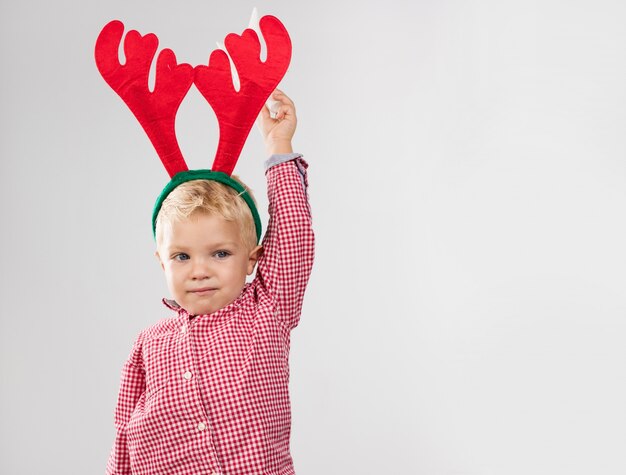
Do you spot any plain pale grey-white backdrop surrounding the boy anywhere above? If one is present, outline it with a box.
[0,0,626,475]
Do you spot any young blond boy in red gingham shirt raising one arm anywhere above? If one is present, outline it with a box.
[107,91,314,475]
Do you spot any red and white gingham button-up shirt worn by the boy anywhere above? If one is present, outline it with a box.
[106,158,314,475]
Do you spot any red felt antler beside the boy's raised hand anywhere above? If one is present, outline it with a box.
[194,15,291,175]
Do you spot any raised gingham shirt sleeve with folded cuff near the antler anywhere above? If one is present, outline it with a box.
[257,155,315,329]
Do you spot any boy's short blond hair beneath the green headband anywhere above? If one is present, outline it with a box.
[156,175,257,249]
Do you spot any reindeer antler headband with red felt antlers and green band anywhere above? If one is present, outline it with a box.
[95,15,291,239]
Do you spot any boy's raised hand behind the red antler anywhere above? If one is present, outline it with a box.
[259,89,298,155]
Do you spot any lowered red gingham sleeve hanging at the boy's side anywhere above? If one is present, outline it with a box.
[106,334,146,475]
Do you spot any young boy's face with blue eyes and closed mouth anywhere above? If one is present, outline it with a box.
[156,213,261,315]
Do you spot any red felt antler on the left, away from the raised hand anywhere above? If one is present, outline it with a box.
[95,20,193,177]
